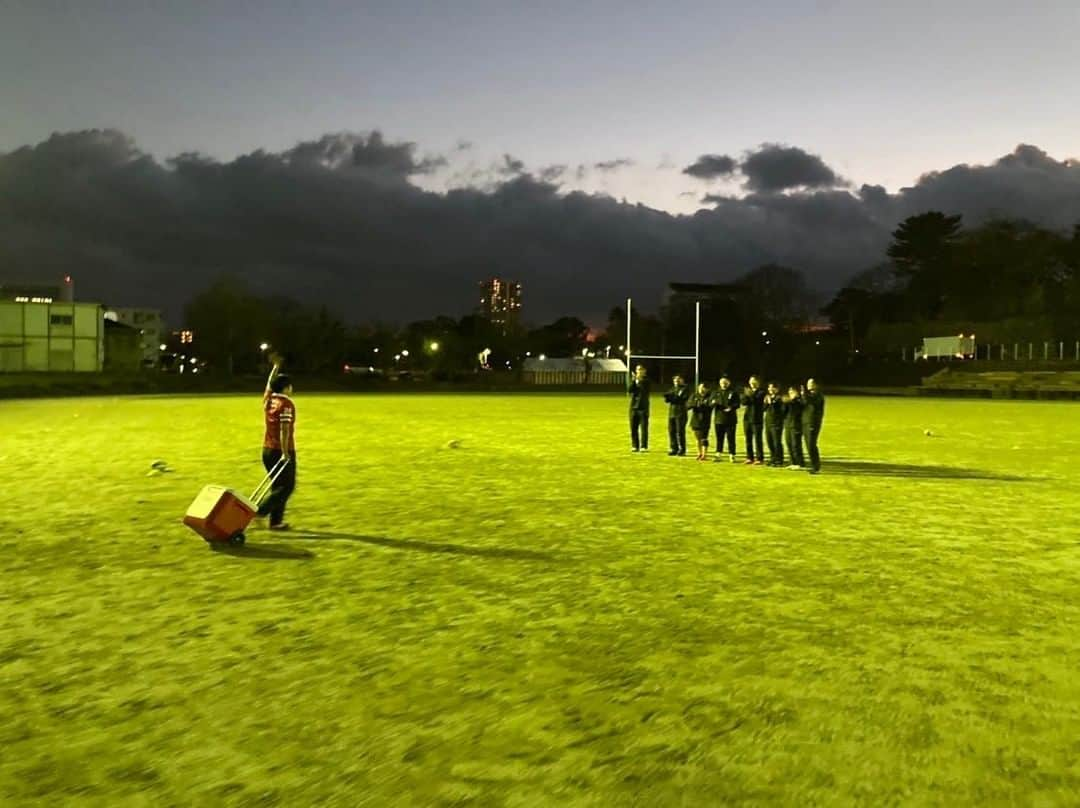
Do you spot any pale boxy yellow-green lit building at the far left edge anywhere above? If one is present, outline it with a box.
[0,298,105,373]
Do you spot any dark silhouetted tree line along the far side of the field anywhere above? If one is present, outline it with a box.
[186,211,1080,379]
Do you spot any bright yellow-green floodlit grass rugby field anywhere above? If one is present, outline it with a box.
[0,391,1080,806]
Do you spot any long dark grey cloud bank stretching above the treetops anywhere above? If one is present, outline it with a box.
[6,131,1080,321]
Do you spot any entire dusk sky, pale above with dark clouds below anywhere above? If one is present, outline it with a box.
[0,0,1080,322]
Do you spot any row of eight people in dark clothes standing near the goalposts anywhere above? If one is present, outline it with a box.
[630,365,825,474]
